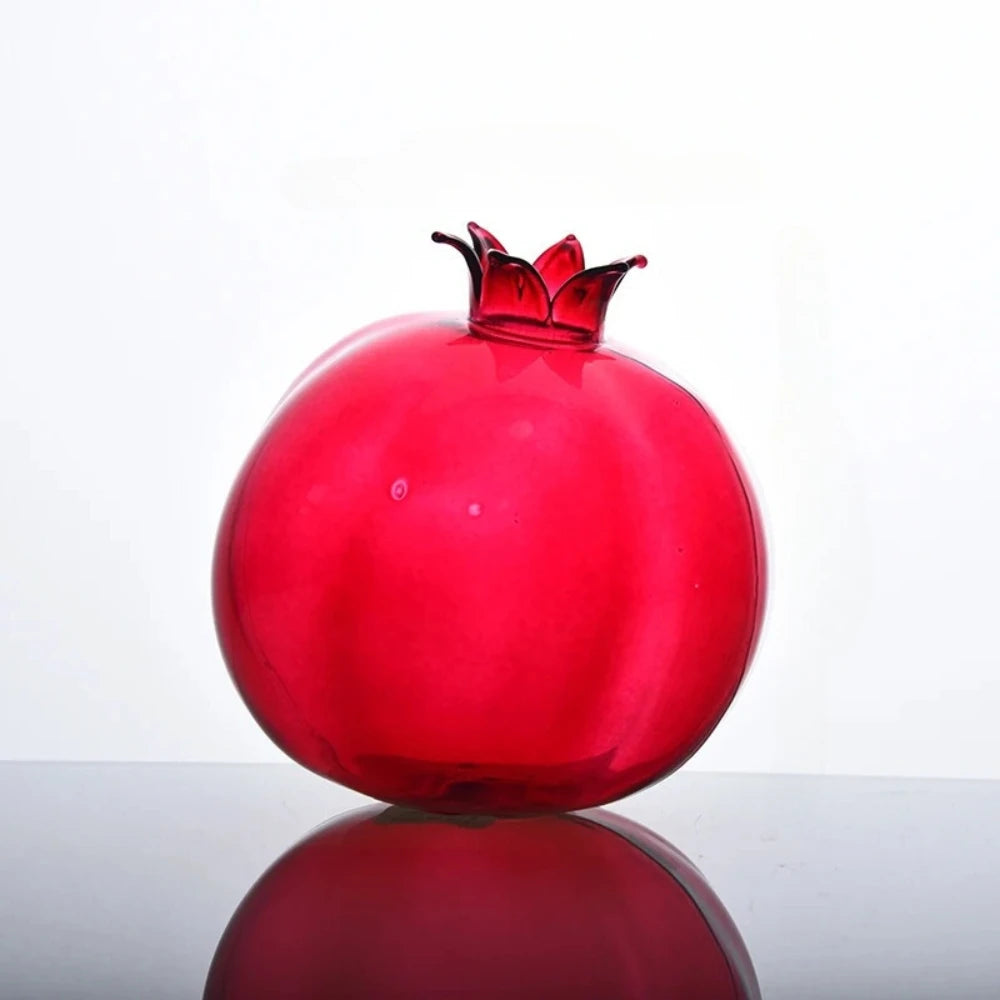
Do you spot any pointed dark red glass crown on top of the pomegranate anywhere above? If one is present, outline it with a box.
[431,222,646,347]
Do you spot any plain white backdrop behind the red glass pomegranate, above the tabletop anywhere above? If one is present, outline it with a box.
[0,0,1000,778]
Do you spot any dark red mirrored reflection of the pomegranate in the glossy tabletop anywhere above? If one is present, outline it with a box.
[205,806,760,1000]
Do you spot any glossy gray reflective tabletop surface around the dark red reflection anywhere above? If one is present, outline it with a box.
[0,764,1000,1000]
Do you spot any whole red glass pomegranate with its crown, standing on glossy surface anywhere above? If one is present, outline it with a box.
[214,225,765,813]
